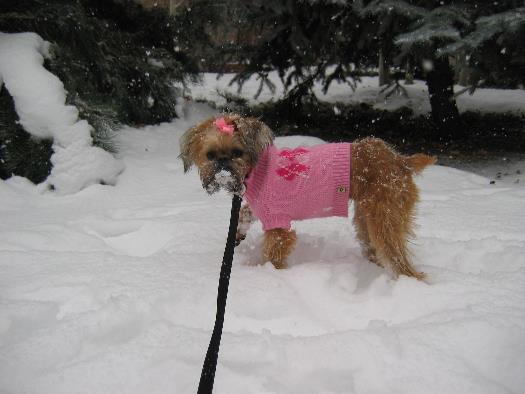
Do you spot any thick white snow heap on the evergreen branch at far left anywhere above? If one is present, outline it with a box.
[0,33,123,194]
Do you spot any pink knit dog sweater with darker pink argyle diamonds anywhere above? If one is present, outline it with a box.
[245,143,351,230]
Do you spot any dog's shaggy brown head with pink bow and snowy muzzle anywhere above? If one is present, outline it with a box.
[180,115,273,194]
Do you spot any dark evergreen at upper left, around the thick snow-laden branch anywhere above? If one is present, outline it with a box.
[0,0,206,182]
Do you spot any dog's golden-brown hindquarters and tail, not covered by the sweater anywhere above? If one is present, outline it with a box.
[350,138,428,279]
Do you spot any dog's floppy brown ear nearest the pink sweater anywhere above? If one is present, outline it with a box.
[233,117,274,164]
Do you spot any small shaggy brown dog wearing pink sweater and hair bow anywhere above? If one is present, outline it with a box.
[179,114,436,280]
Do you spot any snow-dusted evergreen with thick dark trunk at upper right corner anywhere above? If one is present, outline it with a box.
[361,0,525,137]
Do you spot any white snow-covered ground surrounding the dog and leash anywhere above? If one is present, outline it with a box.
[0,102,525,394]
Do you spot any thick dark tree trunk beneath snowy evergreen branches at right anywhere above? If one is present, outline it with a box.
[427,57,462,137]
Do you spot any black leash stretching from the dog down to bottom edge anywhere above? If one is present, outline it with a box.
[197,194,242,394]
